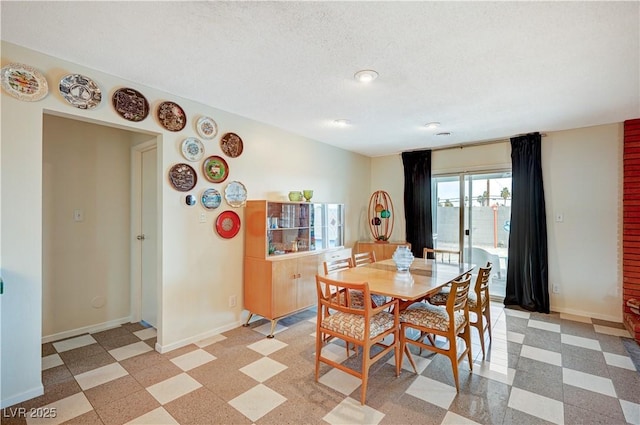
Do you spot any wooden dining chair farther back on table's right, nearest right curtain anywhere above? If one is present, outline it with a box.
[427,262,493,359]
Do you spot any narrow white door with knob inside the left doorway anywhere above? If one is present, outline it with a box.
[140,147,158,327]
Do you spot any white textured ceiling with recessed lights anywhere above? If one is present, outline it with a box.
[0,1,640,156]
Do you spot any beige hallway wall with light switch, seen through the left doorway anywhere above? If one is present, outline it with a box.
[42,115,132,341]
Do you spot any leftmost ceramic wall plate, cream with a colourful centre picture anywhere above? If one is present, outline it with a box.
[0,63,49,102]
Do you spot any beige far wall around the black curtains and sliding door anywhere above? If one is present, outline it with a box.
[371,124,623,322]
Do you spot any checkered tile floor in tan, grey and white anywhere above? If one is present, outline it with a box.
[2,305,640,425]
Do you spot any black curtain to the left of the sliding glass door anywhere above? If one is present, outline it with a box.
[402,150,433,257]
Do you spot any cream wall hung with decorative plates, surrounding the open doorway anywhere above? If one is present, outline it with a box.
[0,42,371,406]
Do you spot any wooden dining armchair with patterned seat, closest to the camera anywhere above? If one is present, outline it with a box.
[316,275,401,405]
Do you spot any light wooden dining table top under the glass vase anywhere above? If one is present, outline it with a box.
[327,258,475,301]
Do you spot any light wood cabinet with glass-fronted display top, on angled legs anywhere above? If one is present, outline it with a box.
[244,201,344,338]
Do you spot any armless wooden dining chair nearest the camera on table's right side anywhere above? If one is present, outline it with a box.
[400,273,473,392]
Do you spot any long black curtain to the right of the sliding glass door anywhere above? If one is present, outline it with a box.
[504,133,549,313]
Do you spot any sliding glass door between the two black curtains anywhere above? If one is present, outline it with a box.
[432,170,511,298]
